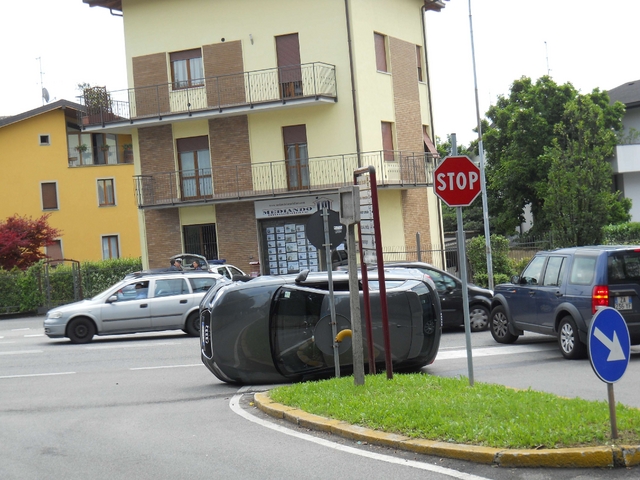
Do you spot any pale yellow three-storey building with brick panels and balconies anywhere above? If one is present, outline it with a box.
[84,0,443,274]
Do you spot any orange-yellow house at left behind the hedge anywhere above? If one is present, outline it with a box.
[0,100,140,261]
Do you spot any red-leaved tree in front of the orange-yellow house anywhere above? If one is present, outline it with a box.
[0,215,61,270]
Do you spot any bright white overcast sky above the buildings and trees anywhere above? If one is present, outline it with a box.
[0,0,640,145]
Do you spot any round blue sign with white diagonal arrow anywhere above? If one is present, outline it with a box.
[588,307,631,383]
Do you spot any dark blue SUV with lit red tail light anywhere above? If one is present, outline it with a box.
[490,245,640,359]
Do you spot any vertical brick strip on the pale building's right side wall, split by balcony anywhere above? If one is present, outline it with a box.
[389,37,431,247]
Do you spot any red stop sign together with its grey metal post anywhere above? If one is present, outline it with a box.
[433,156,482,386]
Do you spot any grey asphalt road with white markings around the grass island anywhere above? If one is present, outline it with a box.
[0,317,640,480]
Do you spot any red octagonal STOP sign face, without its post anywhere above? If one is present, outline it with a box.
[433,155,482,207]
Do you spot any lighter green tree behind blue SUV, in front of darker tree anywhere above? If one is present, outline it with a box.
[540,90,630,246]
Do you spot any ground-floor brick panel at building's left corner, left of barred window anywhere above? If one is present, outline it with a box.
[144,208,182,268]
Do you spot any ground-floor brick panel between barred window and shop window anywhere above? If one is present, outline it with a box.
[216,202,260,273]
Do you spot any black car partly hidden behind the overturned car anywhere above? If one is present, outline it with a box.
[376,262,493,332]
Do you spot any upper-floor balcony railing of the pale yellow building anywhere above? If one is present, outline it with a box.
[79,62,337,126]
